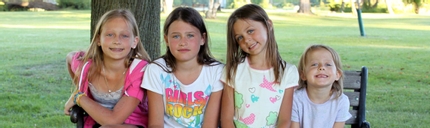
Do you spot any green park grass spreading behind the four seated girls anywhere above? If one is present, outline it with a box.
[0,11,430,128]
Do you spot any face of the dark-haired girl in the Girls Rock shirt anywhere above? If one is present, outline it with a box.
[164,20,205,62]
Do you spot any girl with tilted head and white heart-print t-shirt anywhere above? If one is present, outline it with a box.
[221,4,299,128]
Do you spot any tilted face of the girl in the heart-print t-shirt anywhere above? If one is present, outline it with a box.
[233,19,267,56]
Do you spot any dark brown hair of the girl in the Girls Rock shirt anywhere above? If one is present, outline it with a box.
[157,7,219,73]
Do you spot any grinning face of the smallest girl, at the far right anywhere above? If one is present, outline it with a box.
[300,48,340,88]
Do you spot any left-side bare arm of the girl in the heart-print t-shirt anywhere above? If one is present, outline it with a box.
[221,83,235,128]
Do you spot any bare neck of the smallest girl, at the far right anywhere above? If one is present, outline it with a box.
[306,85,332,104]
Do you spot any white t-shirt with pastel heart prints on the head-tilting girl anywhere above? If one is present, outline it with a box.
[221,59,299,128]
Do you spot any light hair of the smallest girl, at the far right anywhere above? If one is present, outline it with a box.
[297,44,343,99]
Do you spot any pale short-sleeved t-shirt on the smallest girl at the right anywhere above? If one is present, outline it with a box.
[291,88,351,128]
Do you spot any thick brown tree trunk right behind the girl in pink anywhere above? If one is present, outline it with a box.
[91,0,160,58]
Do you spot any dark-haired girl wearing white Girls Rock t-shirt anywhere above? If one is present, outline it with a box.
[141,7,223,128]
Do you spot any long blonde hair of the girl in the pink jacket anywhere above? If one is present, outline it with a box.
[78,9,151,83]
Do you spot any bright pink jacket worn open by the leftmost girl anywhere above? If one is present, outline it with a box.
[71,52,148,128]
